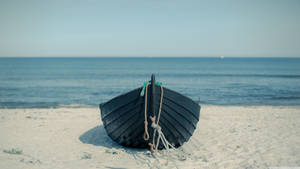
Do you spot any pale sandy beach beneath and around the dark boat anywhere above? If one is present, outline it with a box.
[0,106,300,169]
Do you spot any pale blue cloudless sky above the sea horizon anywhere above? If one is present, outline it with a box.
[0,0,300,57]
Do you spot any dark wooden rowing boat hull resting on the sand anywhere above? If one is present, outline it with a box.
[100,75,200,149]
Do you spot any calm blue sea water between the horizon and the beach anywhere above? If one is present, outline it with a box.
[0,58,300,108]
